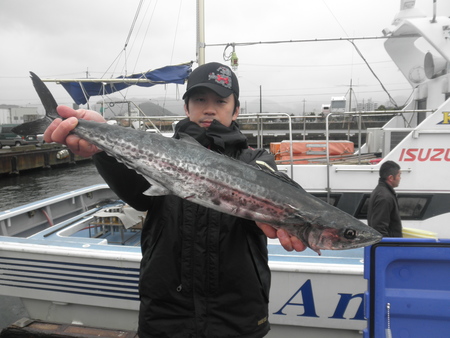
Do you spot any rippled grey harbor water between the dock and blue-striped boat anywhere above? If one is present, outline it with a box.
[0,161,105,211]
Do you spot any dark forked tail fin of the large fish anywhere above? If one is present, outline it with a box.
[12,72,61,136]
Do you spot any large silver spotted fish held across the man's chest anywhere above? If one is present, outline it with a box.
[14,73,381,254]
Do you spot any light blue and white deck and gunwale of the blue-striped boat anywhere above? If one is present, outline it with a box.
[0,190,364,271]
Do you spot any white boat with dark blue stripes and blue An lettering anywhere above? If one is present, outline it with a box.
[0,184,365,337]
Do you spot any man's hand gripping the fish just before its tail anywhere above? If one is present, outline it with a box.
[44,106,106,157]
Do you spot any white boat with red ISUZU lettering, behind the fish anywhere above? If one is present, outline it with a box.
[279,0,450,238]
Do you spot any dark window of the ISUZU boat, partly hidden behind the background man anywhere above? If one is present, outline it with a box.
[355,194,432,220]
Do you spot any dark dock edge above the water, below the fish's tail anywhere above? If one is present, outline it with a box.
[0,143,90,175]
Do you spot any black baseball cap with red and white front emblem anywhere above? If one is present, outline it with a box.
[183,62,239,100]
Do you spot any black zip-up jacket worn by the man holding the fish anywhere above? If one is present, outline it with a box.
[94,119,276,338]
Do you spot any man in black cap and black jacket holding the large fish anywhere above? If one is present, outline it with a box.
[44,63,306,338]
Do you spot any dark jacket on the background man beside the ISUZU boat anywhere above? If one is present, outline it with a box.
[367,178,403,237]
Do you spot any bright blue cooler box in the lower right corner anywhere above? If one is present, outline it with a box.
[364,238,450,338]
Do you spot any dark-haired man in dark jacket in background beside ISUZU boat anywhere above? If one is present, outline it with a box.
[367,161,403,237]
